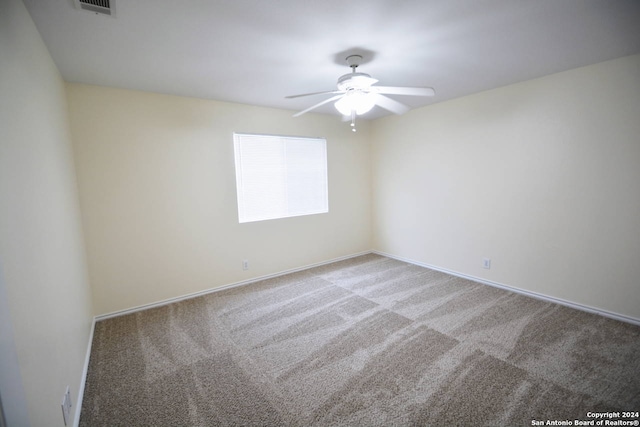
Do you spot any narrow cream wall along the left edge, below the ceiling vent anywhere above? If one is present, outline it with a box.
[0,0,92,426]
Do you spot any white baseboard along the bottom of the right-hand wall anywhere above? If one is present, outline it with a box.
[371,250,640,326]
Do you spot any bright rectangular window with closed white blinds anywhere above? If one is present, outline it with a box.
[233,133,329,223]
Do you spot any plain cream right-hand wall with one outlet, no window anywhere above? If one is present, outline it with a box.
[371,55,640,319]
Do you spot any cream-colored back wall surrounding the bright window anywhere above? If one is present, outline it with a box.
[67,84,371,314]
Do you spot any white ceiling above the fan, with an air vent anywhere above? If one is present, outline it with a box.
[24,0,640,118]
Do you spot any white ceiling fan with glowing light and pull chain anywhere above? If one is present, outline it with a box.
[286,55,436,132]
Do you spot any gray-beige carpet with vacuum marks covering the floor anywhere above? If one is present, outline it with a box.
[80,254,640,426]
